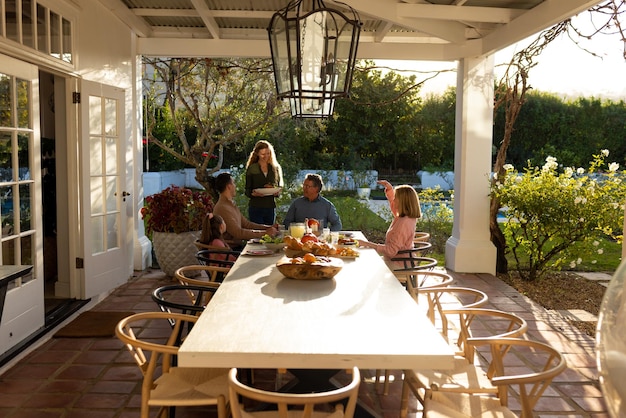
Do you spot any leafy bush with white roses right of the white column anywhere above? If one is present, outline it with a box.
[491,150,626,280]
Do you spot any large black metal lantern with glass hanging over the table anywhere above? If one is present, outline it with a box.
[267,0,362,118]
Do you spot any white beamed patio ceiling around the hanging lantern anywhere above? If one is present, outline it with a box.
[96,0,600,61]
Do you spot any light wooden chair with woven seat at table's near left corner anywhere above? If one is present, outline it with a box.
[115,312,228,418]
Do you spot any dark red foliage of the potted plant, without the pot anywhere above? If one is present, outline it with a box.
[141,186,213,236]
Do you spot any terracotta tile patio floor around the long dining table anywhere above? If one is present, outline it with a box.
[0,270,608,418]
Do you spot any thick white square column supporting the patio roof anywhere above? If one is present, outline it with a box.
[446,55,496,274]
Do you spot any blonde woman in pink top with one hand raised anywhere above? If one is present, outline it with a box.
[359,180,422,264]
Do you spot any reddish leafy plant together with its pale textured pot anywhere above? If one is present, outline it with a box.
[141,186,213,276]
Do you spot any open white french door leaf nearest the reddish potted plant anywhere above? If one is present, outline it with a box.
[80,81,132,298]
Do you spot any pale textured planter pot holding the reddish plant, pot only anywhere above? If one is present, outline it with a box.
[152,231,200,277]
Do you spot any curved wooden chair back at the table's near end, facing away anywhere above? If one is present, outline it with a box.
[228,367,361,418]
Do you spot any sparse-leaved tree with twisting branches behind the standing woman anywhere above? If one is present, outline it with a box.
[144,58,283,195]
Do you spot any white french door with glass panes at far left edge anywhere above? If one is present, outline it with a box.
[0,54,44,354]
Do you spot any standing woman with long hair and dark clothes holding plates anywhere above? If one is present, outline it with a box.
[246,140,283,225]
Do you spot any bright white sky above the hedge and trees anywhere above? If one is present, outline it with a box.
[376,11,626,100]
